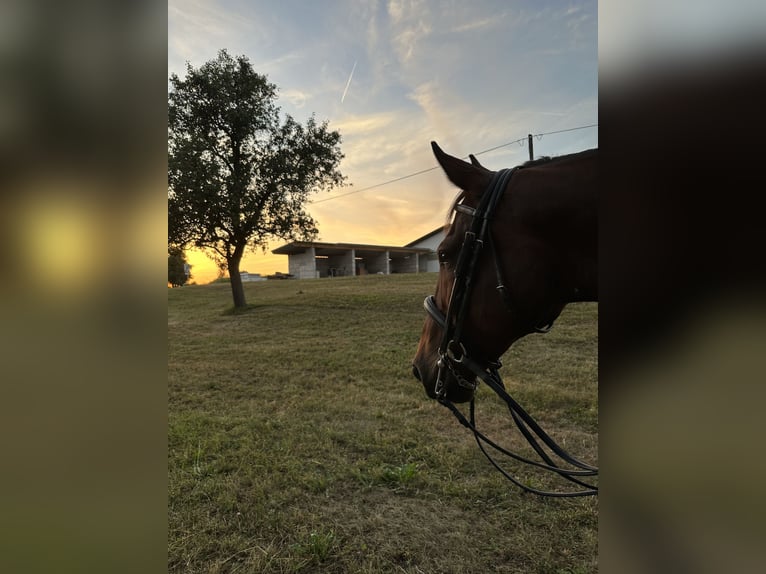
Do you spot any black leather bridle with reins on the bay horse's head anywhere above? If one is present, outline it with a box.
[423,168,598,497]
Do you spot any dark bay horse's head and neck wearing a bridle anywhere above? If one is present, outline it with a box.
[412,142,598,494]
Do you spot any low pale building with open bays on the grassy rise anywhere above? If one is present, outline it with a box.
[272,228,443,279]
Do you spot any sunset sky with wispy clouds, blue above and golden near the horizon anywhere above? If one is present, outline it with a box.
[168,0,598,283]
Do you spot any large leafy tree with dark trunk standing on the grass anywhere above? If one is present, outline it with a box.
[168,50,345,308]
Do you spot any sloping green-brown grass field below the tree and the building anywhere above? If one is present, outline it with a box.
[168,274,598,574]
